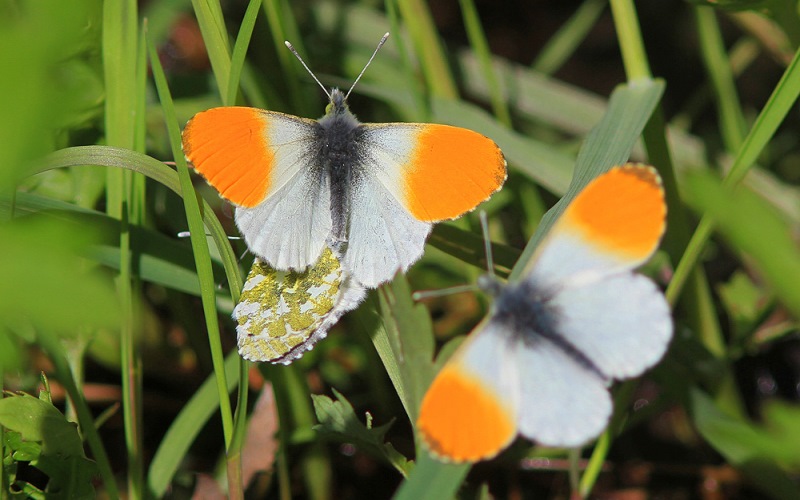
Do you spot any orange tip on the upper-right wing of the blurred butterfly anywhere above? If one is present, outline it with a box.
[562,164,667,259]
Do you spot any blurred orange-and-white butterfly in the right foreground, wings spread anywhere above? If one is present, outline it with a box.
[417,164,673,462]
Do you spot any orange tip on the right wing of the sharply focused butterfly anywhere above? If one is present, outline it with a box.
[404,125,506,222]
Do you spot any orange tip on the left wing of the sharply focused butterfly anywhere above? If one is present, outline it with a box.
[183,107,275,208]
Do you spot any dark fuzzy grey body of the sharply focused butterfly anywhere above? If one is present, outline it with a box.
[318,89,363,241]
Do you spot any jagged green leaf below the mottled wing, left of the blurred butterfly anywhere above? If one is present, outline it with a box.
[311,389,412,476]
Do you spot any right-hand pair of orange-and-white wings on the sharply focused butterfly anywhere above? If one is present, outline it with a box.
[343,123,506,287]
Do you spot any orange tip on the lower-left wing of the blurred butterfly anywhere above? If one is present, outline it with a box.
[417,363,517,462]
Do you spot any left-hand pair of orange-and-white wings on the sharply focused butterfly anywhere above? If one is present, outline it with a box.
[183,107,332,270]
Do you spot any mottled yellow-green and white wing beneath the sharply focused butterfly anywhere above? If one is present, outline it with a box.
[233,247,366,364]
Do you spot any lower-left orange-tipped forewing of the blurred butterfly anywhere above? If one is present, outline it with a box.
[417,320,520,462]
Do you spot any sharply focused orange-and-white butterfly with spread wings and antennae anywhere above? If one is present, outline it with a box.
[183,33,506,288]
